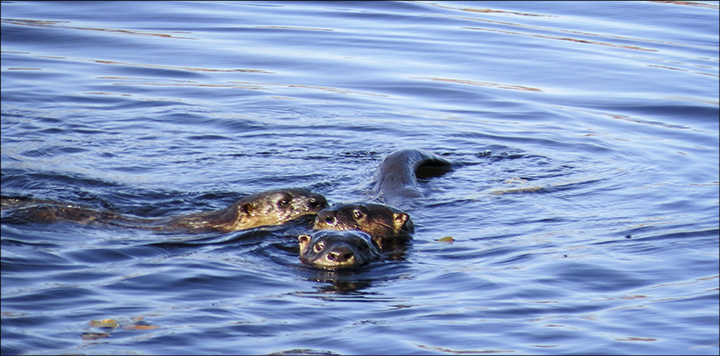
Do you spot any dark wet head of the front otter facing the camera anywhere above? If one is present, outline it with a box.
[298,231,380,269]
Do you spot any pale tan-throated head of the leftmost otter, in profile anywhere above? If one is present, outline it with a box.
[231,189,328,228]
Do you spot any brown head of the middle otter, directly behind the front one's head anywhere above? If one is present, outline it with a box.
[314,203,415,247]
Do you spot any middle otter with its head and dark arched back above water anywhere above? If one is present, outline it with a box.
[313,149,452,252]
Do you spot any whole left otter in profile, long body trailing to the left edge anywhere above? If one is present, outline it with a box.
[2,189,328,232]
